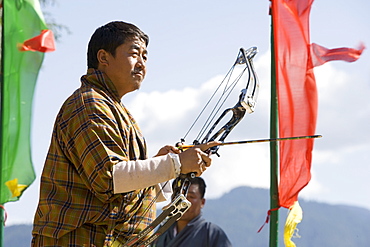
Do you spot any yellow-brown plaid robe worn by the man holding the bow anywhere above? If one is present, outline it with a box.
[33,69,155,238]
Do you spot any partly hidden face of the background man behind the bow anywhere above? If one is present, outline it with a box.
[179,184,206,222]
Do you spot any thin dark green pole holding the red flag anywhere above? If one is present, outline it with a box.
[269,10,279,247]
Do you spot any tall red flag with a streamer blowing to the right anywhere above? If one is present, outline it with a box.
[272,0,364,208]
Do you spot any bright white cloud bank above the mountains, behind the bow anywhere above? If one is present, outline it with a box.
[128,49,370,208]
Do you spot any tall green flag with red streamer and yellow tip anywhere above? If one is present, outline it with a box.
[0,0,54,204]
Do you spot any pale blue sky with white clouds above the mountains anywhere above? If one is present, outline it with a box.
[5,0,370,225]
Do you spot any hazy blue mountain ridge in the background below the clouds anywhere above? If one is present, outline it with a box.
[3,186,370,247]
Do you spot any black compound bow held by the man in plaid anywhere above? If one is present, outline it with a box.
[117,47,259,247]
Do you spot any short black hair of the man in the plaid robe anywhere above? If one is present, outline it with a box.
[87,21,149,69]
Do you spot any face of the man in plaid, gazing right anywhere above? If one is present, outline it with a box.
[99,37,147,97]
